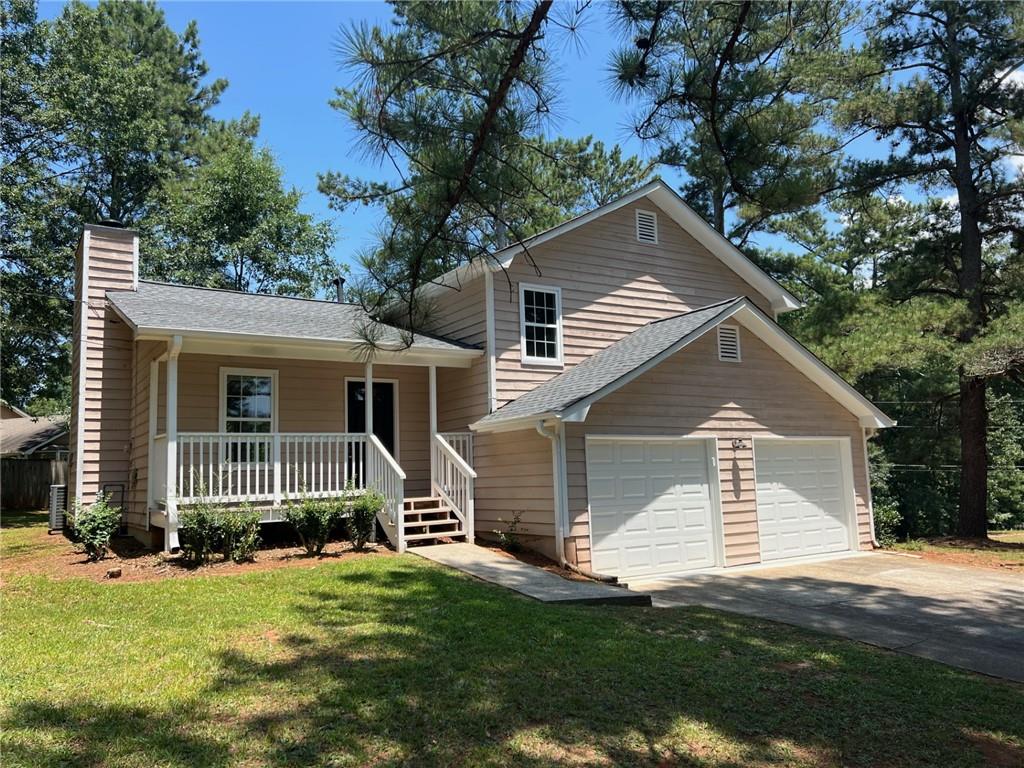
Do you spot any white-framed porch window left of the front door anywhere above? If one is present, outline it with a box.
[220,368,278,462]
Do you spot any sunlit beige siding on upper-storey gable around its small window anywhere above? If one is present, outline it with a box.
[495,201,771,407]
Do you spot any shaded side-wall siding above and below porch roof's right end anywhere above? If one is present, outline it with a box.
[430,276,487,432]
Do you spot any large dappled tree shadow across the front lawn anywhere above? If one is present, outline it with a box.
[5,558,1024,768]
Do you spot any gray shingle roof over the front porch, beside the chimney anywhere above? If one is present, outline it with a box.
[106,281,475,350]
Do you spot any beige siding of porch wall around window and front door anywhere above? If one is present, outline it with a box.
[171,353,430,496]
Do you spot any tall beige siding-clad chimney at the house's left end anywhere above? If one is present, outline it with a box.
[68,222,138,514]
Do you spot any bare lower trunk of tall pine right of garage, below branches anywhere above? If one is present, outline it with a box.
[956,372,988,539]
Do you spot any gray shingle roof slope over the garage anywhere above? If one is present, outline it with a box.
[474,297,745,426]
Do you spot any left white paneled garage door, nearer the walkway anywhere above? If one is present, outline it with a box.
[587,438,717,577]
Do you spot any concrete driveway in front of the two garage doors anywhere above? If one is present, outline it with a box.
[630,553,1024,682]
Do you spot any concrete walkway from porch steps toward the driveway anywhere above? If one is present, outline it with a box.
[408,543,650,605]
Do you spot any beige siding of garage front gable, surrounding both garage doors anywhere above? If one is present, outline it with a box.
[566,329,871,567]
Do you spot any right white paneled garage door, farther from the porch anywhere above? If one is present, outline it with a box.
[754,439,850,560]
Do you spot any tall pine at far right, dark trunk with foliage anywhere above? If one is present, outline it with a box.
[843,0,1024,537]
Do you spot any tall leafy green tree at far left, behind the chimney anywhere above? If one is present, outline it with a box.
[0,0,224,410]
